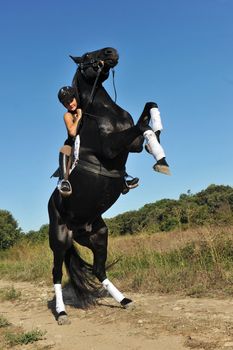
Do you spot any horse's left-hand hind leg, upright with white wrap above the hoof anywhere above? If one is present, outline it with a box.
[49,198,72,325]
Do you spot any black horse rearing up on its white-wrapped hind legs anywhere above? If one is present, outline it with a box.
[48,48,153,324]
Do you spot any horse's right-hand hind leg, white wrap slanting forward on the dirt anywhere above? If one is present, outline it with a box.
[90,218,132,308]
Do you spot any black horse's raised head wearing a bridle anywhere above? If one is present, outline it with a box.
[70,47,119,81]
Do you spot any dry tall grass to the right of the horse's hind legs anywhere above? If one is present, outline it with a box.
[106,227,233,296]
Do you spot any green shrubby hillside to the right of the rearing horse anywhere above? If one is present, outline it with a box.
[105,185,233,235]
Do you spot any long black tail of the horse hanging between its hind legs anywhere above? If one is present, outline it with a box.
[65,245,102,308]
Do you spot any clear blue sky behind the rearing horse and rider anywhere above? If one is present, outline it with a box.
[0,0,233,232]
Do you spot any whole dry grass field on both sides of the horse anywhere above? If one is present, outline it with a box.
[0,226,233,297]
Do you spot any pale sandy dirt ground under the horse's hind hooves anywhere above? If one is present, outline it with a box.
[0,280,233,350]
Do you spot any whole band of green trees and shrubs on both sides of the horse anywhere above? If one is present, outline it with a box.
[0,185,233,250]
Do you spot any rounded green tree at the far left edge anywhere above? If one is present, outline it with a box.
[0,210,22,250]
